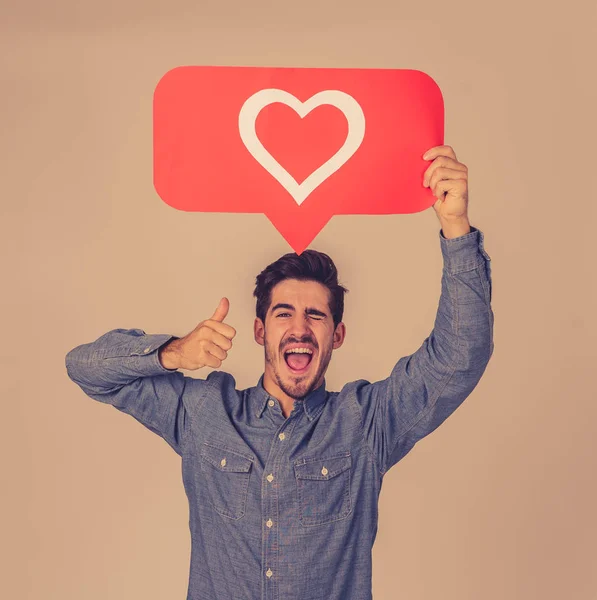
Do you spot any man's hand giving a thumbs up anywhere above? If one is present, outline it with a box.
[158,298,236,371]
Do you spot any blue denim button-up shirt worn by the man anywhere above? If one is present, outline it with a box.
[66,227,493,600]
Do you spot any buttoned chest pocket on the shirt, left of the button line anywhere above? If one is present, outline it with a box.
[199,442,253,519]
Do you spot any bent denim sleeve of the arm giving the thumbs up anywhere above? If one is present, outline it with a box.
[65,329,205,455]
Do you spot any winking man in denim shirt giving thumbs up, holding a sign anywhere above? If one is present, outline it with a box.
[66,146,493,600]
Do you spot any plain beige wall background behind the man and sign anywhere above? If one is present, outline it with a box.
[0,0,597,600]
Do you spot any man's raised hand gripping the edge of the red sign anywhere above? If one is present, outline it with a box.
[423,146,468,221]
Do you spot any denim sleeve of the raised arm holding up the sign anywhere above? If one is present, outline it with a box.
[348,226,494,476]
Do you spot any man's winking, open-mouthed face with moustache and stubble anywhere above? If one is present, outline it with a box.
[255,279,345,399]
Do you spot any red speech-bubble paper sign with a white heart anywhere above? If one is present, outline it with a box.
[153,67,444,254]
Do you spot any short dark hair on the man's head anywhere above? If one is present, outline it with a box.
[253,250,348,328]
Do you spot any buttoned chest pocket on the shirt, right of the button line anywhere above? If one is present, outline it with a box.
[294,452,352,527]
